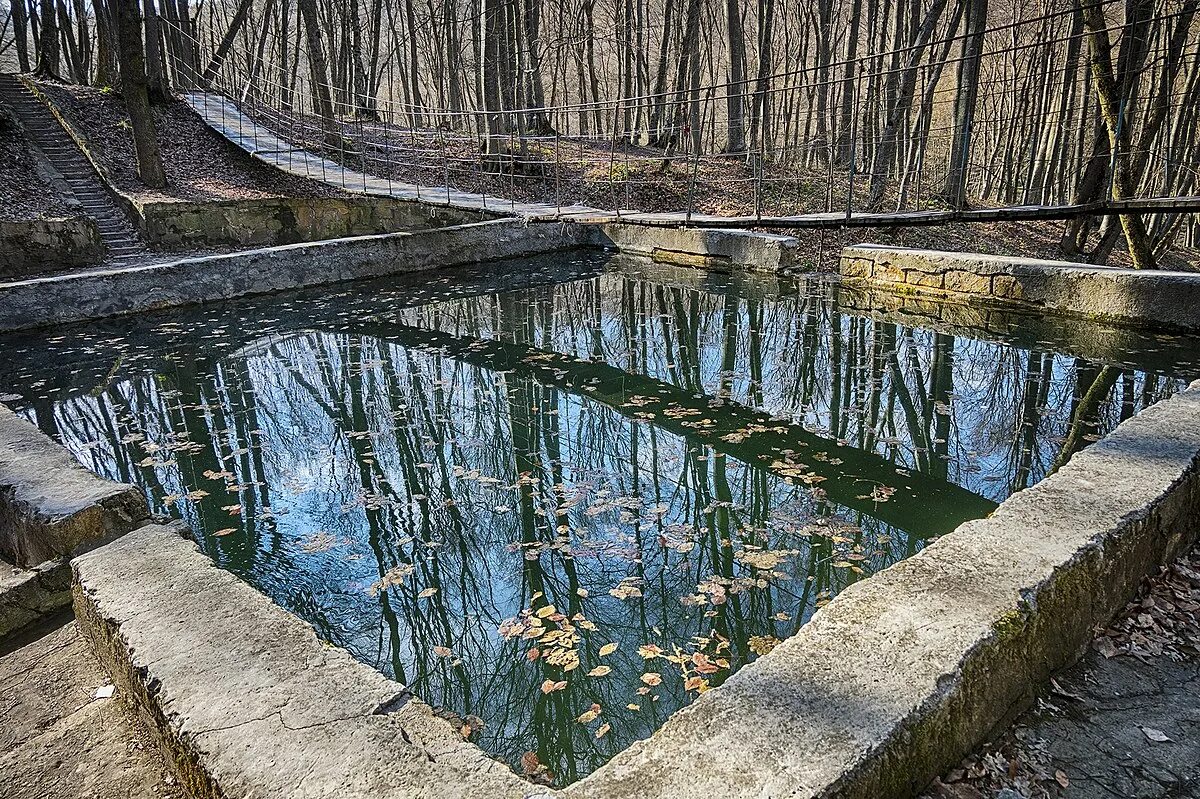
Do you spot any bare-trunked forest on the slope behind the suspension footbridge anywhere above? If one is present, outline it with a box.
[0,0,1200,266]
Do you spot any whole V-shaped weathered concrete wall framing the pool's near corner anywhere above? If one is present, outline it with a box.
[74,384,1200,799]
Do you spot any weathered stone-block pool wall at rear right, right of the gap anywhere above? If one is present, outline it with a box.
[839,245,1200,331]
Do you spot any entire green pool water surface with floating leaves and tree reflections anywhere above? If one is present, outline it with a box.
[0,253,1200,785]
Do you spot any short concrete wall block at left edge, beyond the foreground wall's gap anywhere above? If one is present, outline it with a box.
[0,405,150,569]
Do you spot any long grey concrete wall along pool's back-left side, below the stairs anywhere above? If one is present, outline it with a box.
[0,220,586,330]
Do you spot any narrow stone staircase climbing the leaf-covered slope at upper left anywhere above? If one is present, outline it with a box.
[0,74,146,263]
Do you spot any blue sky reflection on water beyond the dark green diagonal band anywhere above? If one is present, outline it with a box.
[402,272,1182,501]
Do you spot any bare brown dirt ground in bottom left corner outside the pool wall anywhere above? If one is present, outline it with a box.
[0,615,185,799]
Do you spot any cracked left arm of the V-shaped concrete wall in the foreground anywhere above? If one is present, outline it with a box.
[73,525,538,799]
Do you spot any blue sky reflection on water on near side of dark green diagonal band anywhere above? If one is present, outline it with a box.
[39,321,910,772]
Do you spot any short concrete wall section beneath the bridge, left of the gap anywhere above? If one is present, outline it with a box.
[592,223,799,272]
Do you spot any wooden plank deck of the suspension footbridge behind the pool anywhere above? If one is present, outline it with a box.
[186,92,1200,229]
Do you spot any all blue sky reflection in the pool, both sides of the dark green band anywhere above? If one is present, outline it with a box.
[7,257,1178,770]
